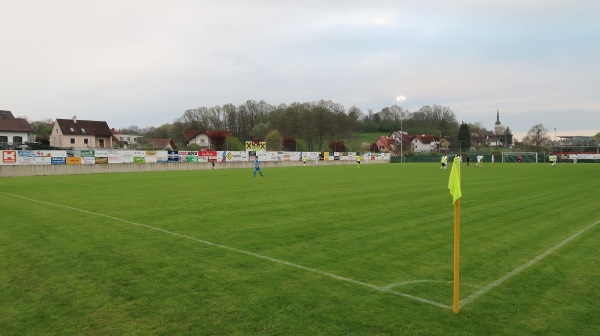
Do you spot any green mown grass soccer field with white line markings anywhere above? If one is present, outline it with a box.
[0,163,600,335]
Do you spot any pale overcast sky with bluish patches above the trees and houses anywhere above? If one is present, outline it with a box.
[0,0,600,138]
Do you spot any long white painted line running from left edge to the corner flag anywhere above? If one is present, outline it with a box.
[0,191,452,309]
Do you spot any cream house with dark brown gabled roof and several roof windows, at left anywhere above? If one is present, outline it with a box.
[50,117,113,149]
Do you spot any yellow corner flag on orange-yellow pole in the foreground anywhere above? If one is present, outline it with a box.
[448,156,462,314]
